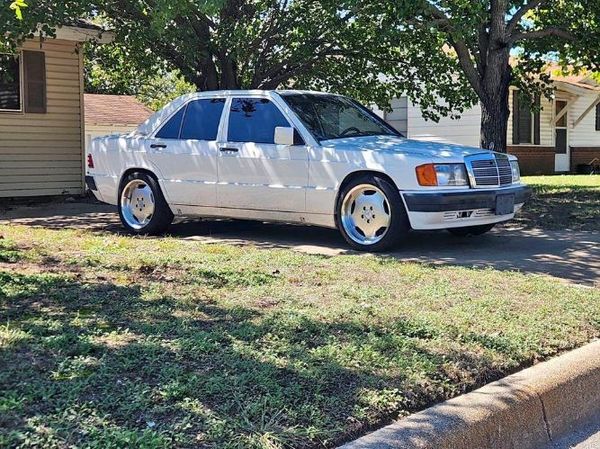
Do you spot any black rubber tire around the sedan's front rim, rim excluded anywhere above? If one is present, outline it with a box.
[335,175,410,252]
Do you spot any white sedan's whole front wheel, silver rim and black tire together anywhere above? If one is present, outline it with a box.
[336,175,410,251]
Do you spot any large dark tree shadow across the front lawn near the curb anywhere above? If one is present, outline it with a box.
[0,272,536,448]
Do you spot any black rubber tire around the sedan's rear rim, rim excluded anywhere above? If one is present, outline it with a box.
[119,172,174,235]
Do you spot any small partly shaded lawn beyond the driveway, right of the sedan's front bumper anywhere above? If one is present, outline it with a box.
[517,175,600,231]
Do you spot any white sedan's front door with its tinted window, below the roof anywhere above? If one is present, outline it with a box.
[217,97,308,212]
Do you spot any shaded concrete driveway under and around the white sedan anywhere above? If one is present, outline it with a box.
[0,202,600,286]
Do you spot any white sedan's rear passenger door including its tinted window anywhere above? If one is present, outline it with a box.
[147,98,225,207]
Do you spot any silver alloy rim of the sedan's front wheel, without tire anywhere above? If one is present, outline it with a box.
[340,184,392,245]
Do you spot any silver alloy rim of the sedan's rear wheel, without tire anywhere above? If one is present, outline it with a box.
[121,179,155,230]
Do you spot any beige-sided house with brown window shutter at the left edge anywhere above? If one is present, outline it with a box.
[0,21,112,198]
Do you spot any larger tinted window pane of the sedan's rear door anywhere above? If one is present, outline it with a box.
[181,98,225,140]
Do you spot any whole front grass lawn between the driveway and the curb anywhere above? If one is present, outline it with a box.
[0,219,600,449]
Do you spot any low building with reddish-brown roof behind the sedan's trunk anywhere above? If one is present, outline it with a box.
[84,94,154,148]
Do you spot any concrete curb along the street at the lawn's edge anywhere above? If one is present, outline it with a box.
[340,341,600,449]
